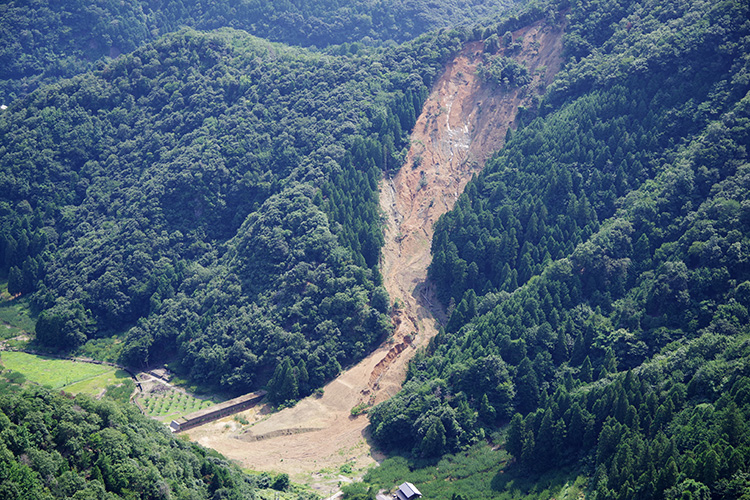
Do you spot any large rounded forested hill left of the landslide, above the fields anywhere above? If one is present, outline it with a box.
[0,27,470,394]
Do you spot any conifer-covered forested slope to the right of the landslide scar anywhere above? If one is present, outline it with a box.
[370,0,750,498]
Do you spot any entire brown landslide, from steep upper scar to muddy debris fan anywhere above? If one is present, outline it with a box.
[187,23,562,494]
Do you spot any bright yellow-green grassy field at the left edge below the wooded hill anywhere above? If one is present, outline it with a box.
[0,351,130,396]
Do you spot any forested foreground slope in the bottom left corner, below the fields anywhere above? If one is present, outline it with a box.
[0,374,264,500]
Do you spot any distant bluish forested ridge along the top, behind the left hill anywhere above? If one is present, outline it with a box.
[0,0,520,104]
